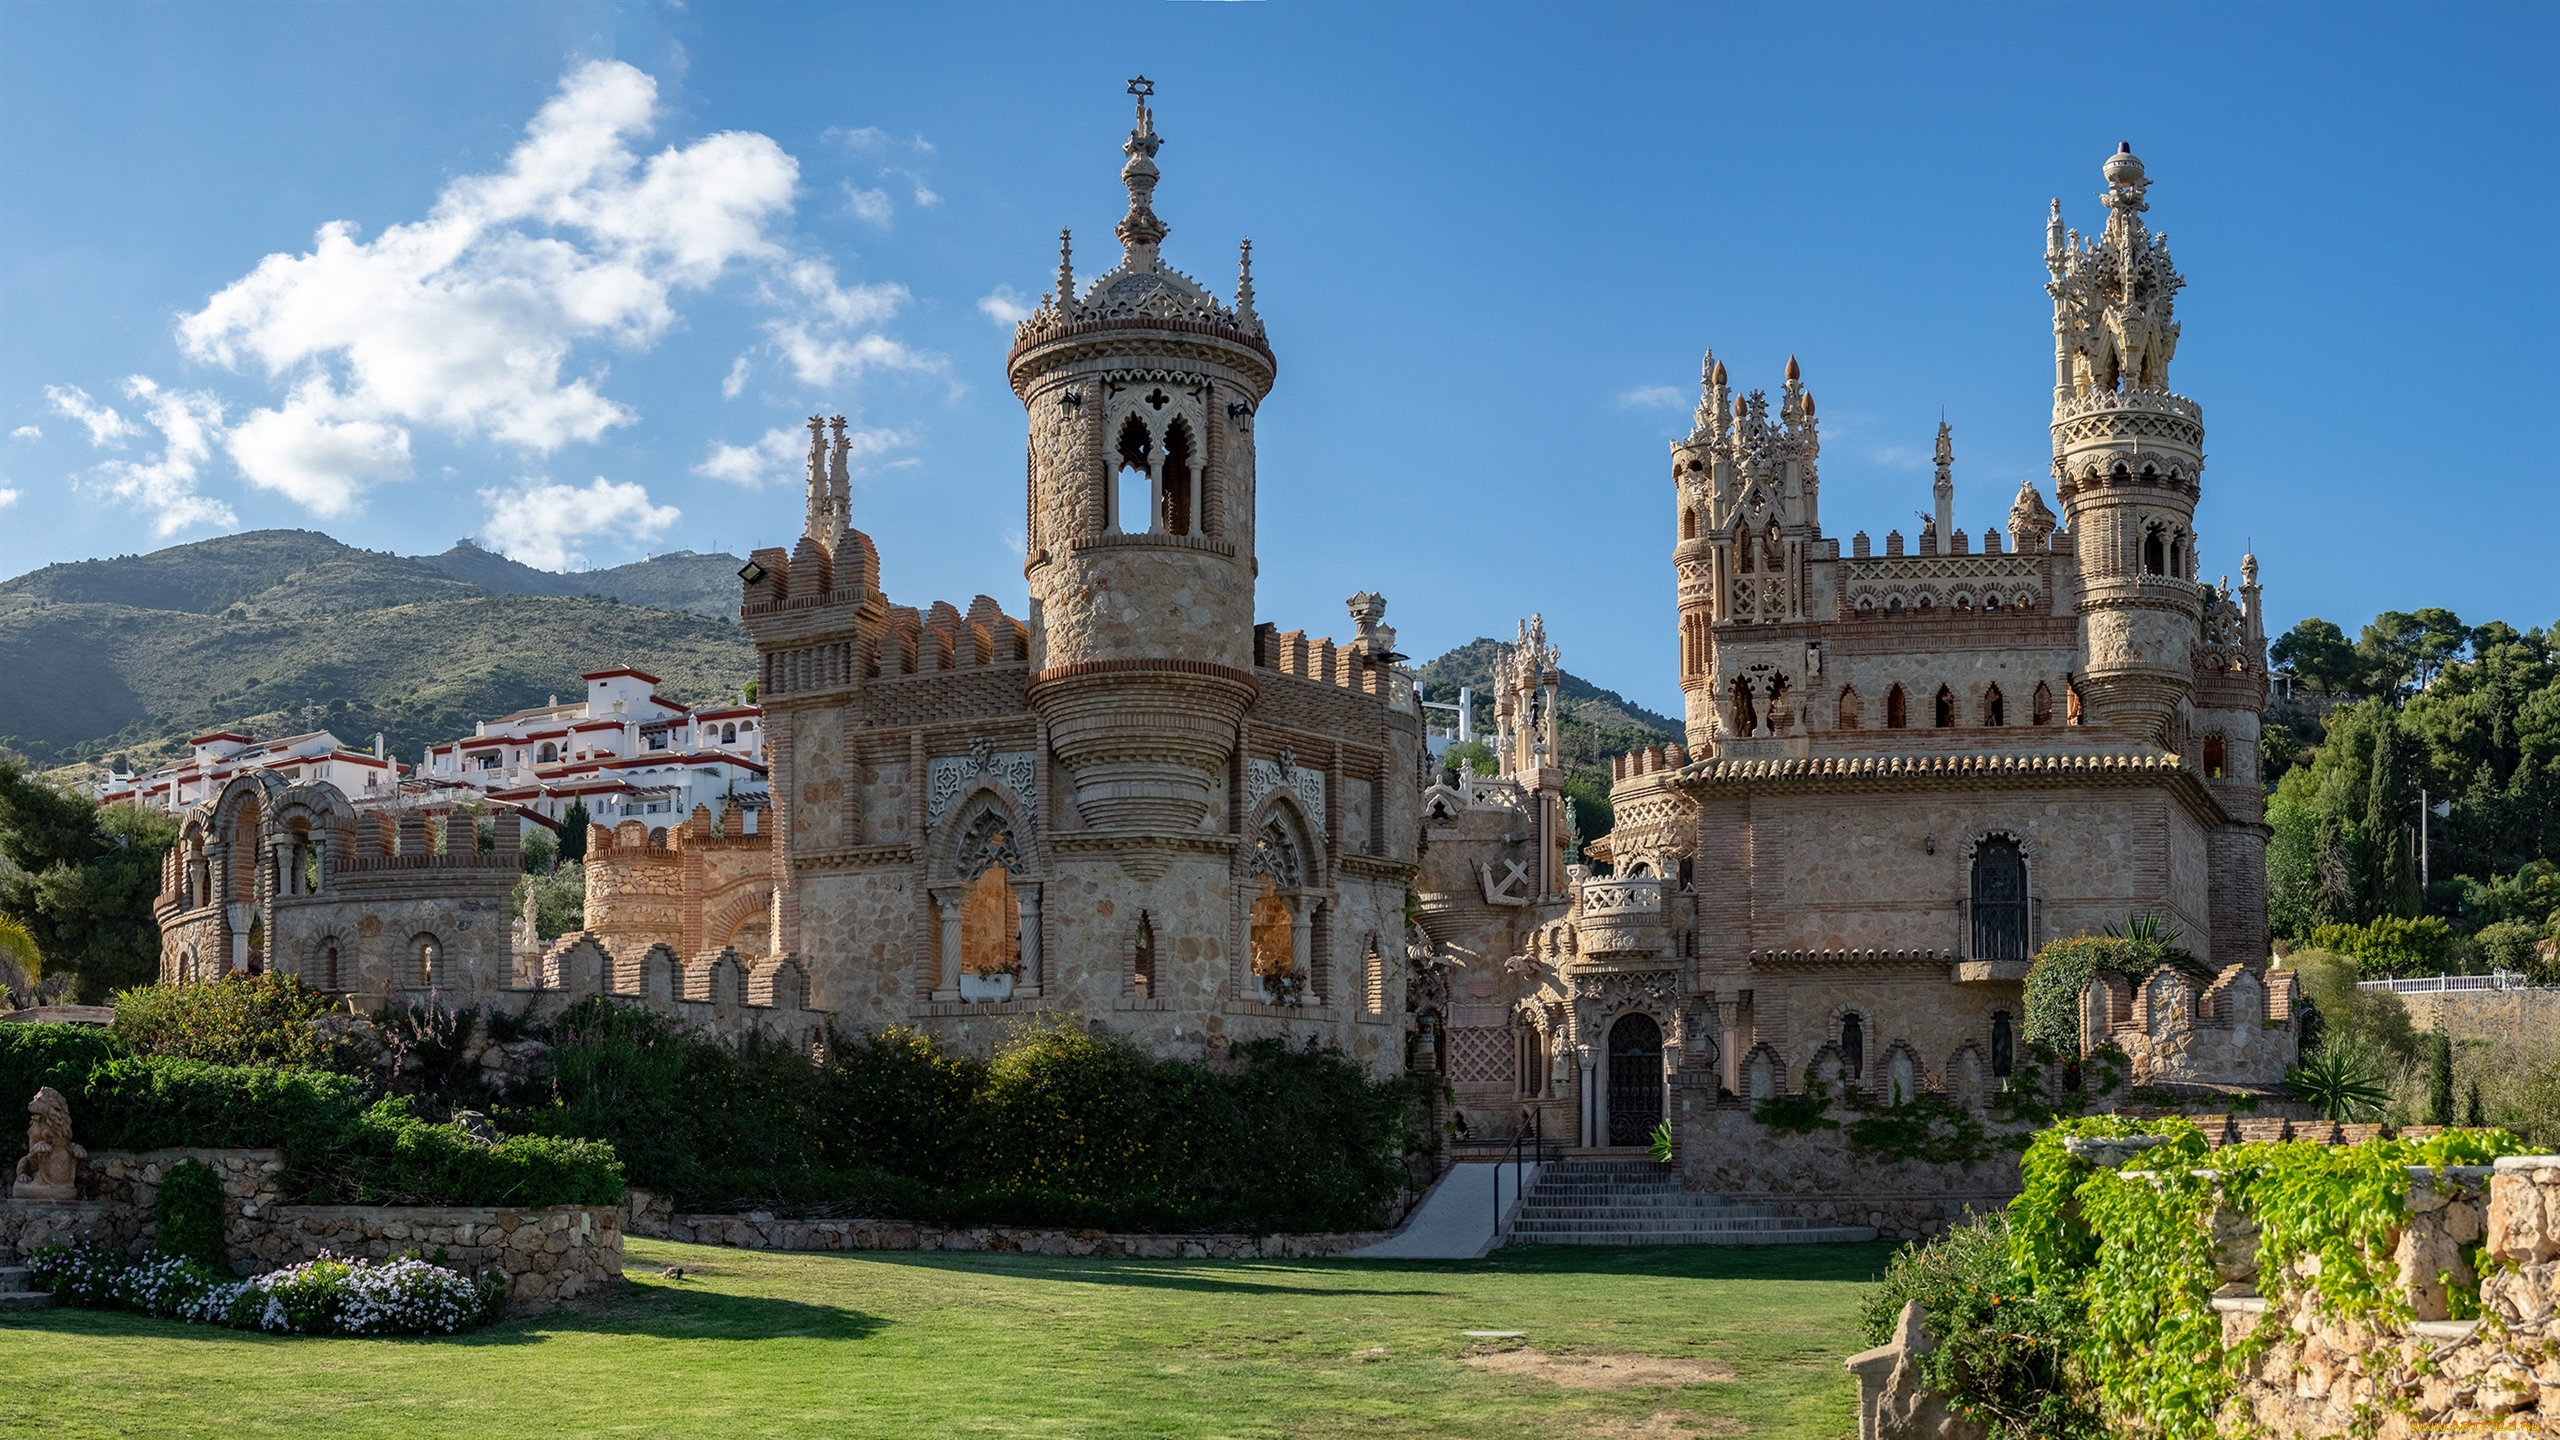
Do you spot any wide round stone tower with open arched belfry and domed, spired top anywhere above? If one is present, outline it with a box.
[1006,77,1277,833]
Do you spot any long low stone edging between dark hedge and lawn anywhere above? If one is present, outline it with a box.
[650,1212,1388,1261]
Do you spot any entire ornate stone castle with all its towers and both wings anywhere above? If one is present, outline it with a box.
[145,97,2294,1145]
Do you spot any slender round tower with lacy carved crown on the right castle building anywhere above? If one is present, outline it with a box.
[2045,146,2204,740]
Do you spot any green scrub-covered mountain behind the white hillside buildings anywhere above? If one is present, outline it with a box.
[0,530,755,766]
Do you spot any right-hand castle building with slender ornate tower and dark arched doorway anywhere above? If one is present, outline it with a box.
[1418,137,2291,1145]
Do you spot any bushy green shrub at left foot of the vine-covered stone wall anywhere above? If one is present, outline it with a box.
[1861,1217,2104,1440]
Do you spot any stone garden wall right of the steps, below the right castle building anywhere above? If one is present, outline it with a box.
[1677,1099,2017,1240]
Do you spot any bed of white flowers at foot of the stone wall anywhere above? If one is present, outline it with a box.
[26,1245,507,1335]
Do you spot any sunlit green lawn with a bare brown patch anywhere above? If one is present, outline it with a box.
[0,1240,1889,1440]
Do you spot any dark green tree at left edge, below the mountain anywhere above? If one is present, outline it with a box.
[0,756,177,1004]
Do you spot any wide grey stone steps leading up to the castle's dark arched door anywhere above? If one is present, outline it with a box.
[1505,1156,1876,1245]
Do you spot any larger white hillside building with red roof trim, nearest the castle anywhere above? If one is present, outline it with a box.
[417,666,768,828]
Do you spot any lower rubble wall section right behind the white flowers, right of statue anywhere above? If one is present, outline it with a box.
[248,1204,622,1314]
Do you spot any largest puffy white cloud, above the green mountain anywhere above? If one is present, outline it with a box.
[179,61,799,515]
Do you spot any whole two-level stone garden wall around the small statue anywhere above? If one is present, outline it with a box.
[0,1148,622,1312]
